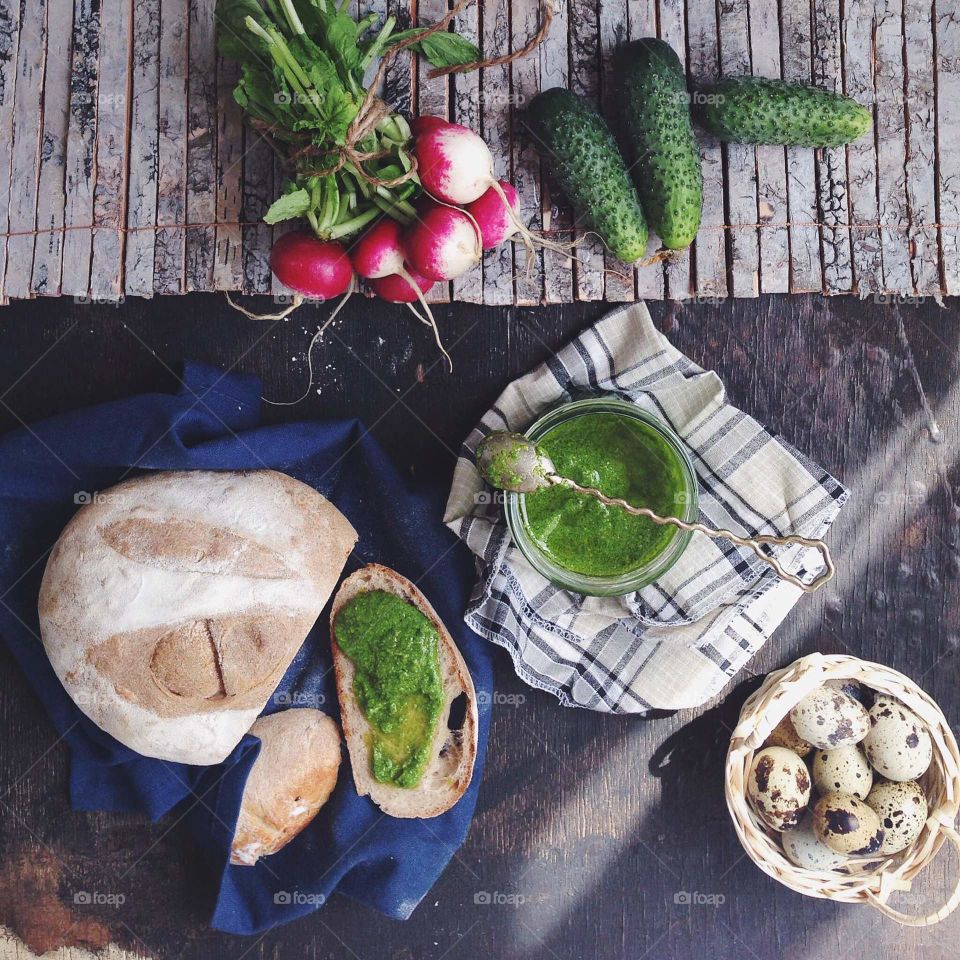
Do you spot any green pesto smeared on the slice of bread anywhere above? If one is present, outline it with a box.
[334,590,443,787]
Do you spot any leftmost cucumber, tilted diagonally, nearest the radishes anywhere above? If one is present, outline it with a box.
[523,87,647,263]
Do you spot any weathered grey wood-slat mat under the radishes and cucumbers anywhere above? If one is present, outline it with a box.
[0,0,960,304]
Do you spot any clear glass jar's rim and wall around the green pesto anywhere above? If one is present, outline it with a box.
[504,396,699,597]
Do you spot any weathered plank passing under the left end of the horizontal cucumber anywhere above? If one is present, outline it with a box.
[687,3,728,297]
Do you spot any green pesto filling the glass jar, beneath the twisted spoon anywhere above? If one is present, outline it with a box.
[524,413,686,577]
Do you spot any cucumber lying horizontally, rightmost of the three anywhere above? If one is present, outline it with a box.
[694,77,873,147]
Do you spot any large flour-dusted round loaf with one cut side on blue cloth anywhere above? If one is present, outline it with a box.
[39,470,357,764]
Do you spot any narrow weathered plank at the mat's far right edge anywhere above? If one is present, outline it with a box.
[934,4,960,294]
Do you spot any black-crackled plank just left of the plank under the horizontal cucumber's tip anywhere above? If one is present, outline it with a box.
[812,0,853,293]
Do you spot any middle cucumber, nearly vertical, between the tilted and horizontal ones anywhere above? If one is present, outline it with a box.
[613,38,703,250]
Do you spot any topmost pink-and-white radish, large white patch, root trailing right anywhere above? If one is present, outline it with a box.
[413,123,573,266]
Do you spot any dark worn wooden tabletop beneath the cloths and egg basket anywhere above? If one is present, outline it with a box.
[0,296,960,960]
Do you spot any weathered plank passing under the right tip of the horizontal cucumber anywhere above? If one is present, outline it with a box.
[842,0,883,297]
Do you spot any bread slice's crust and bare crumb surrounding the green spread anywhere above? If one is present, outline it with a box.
[330,563,477,818]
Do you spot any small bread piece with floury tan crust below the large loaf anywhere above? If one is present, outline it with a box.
[230,708,340,867]
